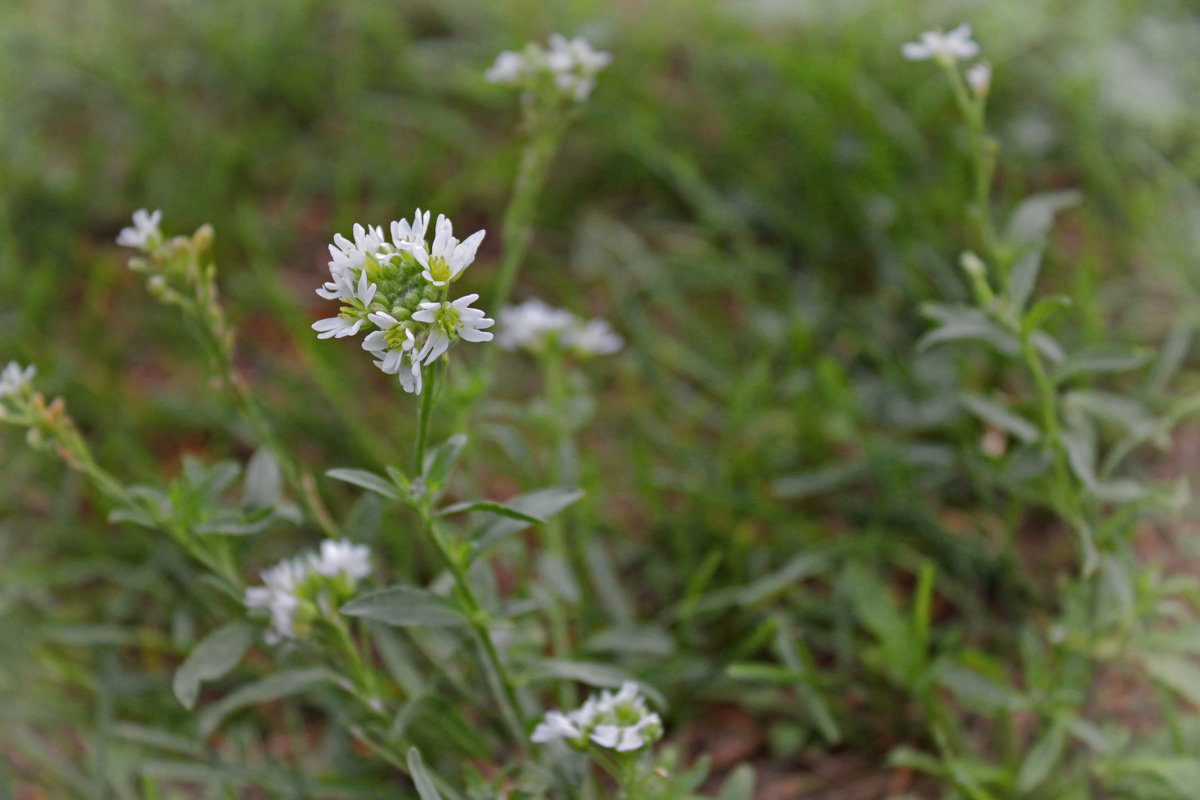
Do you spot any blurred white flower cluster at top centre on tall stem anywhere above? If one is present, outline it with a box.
[484,34,612,103]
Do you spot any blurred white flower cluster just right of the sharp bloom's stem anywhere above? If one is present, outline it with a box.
[496,297,625,356]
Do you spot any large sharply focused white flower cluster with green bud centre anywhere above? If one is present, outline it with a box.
[312,209,494,393]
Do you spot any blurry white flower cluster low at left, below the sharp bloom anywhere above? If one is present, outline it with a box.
[245,539,371,644]
